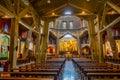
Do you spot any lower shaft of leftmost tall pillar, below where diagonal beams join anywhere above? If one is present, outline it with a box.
[9,18,19,68]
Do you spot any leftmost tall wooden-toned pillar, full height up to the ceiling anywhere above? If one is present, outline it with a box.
[9,0,20,69]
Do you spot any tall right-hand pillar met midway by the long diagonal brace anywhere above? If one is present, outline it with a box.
[97,3,107,63]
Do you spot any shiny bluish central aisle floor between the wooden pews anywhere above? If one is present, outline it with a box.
[62,61,79,80]
